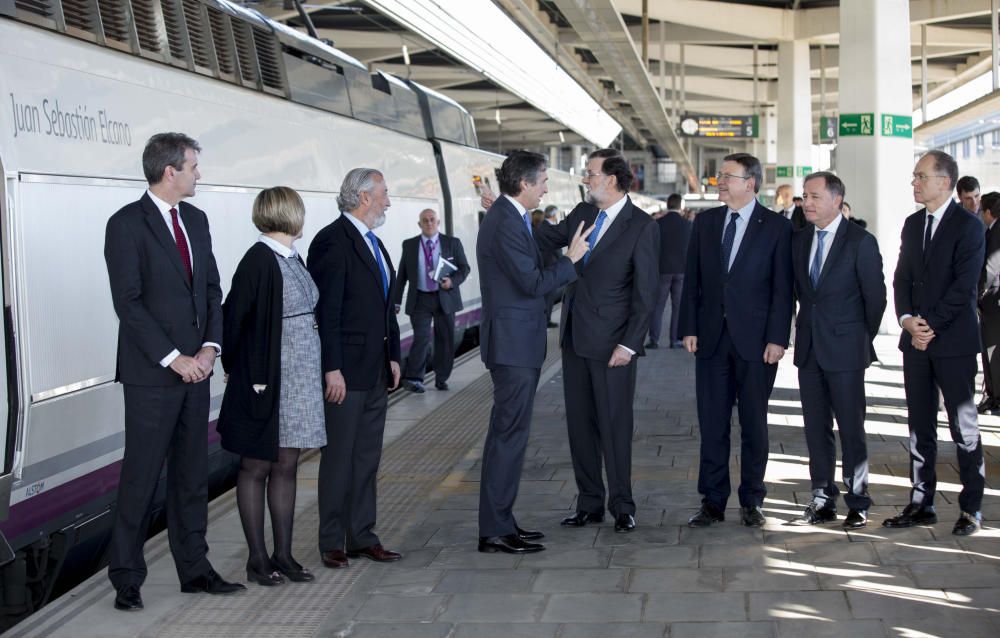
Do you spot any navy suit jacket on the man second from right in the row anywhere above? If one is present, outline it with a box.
[792,218,886,372]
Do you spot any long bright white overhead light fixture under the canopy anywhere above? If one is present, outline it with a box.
[365,0,621,146]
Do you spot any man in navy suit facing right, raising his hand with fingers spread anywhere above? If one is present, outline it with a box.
[476,151,587,554]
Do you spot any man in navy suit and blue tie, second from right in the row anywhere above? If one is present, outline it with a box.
[791,172,886,529]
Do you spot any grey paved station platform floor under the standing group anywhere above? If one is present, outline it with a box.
[5,330,1000,638]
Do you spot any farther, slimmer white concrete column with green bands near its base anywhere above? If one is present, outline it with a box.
[777,40,812,194]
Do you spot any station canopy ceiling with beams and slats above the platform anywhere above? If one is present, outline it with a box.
[247,0,991,184]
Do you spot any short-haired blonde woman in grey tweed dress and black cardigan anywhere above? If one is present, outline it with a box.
[218,186,326,586]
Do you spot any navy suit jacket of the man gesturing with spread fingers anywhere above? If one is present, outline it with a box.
[476,196,577,368]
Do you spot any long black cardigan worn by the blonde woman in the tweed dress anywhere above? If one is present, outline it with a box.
[217,242,286,461]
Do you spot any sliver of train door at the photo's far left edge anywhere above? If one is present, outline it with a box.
[0,157,18,565]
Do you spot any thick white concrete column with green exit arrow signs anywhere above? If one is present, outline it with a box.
[837,0,916,333]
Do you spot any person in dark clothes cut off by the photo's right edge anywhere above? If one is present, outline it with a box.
[966,191,1000,414]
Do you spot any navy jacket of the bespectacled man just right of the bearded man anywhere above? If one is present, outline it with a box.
[678,202,792,361]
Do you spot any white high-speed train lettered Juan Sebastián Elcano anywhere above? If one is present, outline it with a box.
[0,0,661,627]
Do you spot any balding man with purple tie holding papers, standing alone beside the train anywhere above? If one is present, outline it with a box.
[393,208,470,393]
